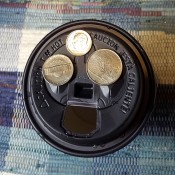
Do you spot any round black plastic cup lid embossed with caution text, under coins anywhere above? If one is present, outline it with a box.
[23,20,156,157]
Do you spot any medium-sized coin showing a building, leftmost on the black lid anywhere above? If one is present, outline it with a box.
[42,54,73,86]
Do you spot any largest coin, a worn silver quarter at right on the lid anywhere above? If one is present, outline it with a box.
[86,49,123,85]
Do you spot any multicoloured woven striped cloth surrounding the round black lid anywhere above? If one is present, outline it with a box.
[0,0,175,175]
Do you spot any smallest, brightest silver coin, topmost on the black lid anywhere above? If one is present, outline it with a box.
[66,30,92,56]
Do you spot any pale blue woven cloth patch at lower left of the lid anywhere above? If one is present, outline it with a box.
[4,127,50,175]
